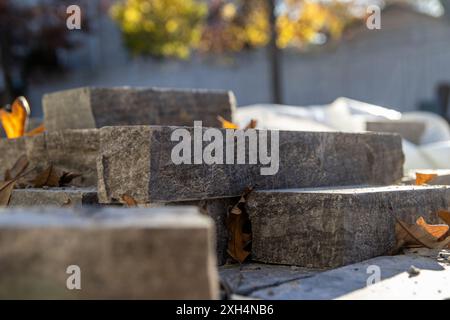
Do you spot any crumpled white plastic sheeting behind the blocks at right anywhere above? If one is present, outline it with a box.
[234,98,450,172]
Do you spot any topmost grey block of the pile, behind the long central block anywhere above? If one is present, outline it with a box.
[43,87,236,131]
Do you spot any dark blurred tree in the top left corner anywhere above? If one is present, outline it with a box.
[0,0,87,104]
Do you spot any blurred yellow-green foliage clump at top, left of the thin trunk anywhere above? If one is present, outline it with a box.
[111,0,207,58]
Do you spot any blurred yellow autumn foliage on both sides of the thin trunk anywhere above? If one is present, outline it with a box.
[111,0,366,58]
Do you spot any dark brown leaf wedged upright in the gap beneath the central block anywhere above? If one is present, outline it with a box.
[227,188,252,263]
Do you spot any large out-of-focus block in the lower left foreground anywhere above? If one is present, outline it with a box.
[0,207,218,299]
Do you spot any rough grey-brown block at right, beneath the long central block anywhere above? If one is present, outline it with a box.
[247,186,450,268]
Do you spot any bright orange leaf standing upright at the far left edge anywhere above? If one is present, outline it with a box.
[0,97,30,139]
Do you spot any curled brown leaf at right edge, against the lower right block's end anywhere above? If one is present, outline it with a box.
[396,219,450,249]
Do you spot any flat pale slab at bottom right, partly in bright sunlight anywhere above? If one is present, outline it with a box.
[249,255,450,300]
